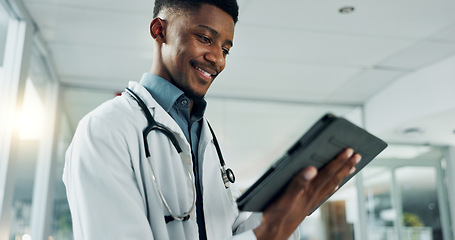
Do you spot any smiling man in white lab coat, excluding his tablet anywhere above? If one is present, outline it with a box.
[63,0,360,239]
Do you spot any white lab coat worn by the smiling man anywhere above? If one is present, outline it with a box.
[63,82,298,240]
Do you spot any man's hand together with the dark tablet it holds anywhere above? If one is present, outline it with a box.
[246,114,387,240]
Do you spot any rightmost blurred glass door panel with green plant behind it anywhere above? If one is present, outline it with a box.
[362,145,451,240]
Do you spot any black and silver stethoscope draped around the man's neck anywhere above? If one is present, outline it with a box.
[126,88,235,223]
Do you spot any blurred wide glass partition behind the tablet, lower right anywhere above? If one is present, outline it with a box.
[300,145,452,240]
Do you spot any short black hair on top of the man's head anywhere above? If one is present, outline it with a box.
[153,0,239,24]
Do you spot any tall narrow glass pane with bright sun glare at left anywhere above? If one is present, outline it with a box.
[10,47,51,239]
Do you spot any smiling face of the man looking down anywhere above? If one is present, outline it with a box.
[158,4,234,98]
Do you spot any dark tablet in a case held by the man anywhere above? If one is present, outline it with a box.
[237,114,387,212]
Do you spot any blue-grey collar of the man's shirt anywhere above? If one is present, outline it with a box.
[140,73,207,119]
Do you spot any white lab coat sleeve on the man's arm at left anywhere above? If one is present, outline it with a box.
[63,114,154,240]
